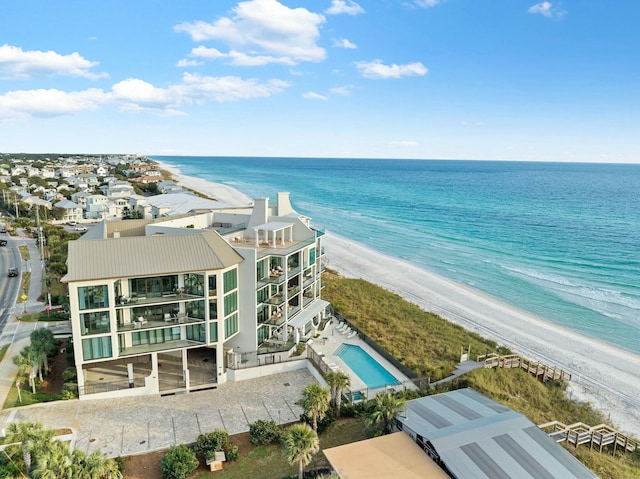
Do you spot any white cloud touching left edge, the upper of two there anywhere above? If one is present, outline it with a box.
[0,44,107,80]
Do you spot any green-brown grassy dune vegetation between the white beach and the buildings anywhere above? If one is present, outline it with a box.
[323,272,640,479]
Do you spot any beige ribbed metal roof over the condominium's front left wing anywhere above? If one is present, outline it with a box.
[63,231,243,282]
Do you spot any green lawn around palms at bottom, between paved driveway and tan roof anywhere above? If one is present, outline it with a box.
[195,418,370,479]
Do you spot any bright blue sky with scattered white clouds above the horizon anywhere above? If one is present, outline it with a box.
[0,0,640,163]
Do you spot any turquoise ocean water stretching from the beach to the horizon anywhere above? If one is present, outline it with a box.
[153,156,640,353]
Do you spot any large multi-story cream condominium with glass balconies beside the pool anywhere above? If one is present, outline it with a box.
[64,193,330,398]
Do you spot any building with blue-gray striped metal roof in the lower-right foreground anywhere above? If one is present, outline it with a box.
[397,388,598,479]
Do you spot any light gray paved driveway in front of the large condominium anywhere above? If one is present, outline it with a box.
[0,369,315,457]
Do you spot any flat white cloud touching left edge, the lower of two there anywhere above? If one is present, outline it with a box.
[0,88,109,120]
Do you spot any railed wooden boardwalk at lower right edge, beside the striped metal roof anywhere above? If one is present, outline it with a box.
[538,421,640,455]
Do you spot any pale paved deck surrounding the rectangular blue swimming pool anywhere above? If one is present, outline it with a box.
[311,319,415,399]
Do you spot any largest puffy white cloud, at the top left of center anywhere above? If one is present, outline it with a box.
[174,0,326,66]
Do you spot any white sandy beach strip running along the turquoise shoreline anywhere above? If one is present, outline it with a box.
[155,163,640,437]
